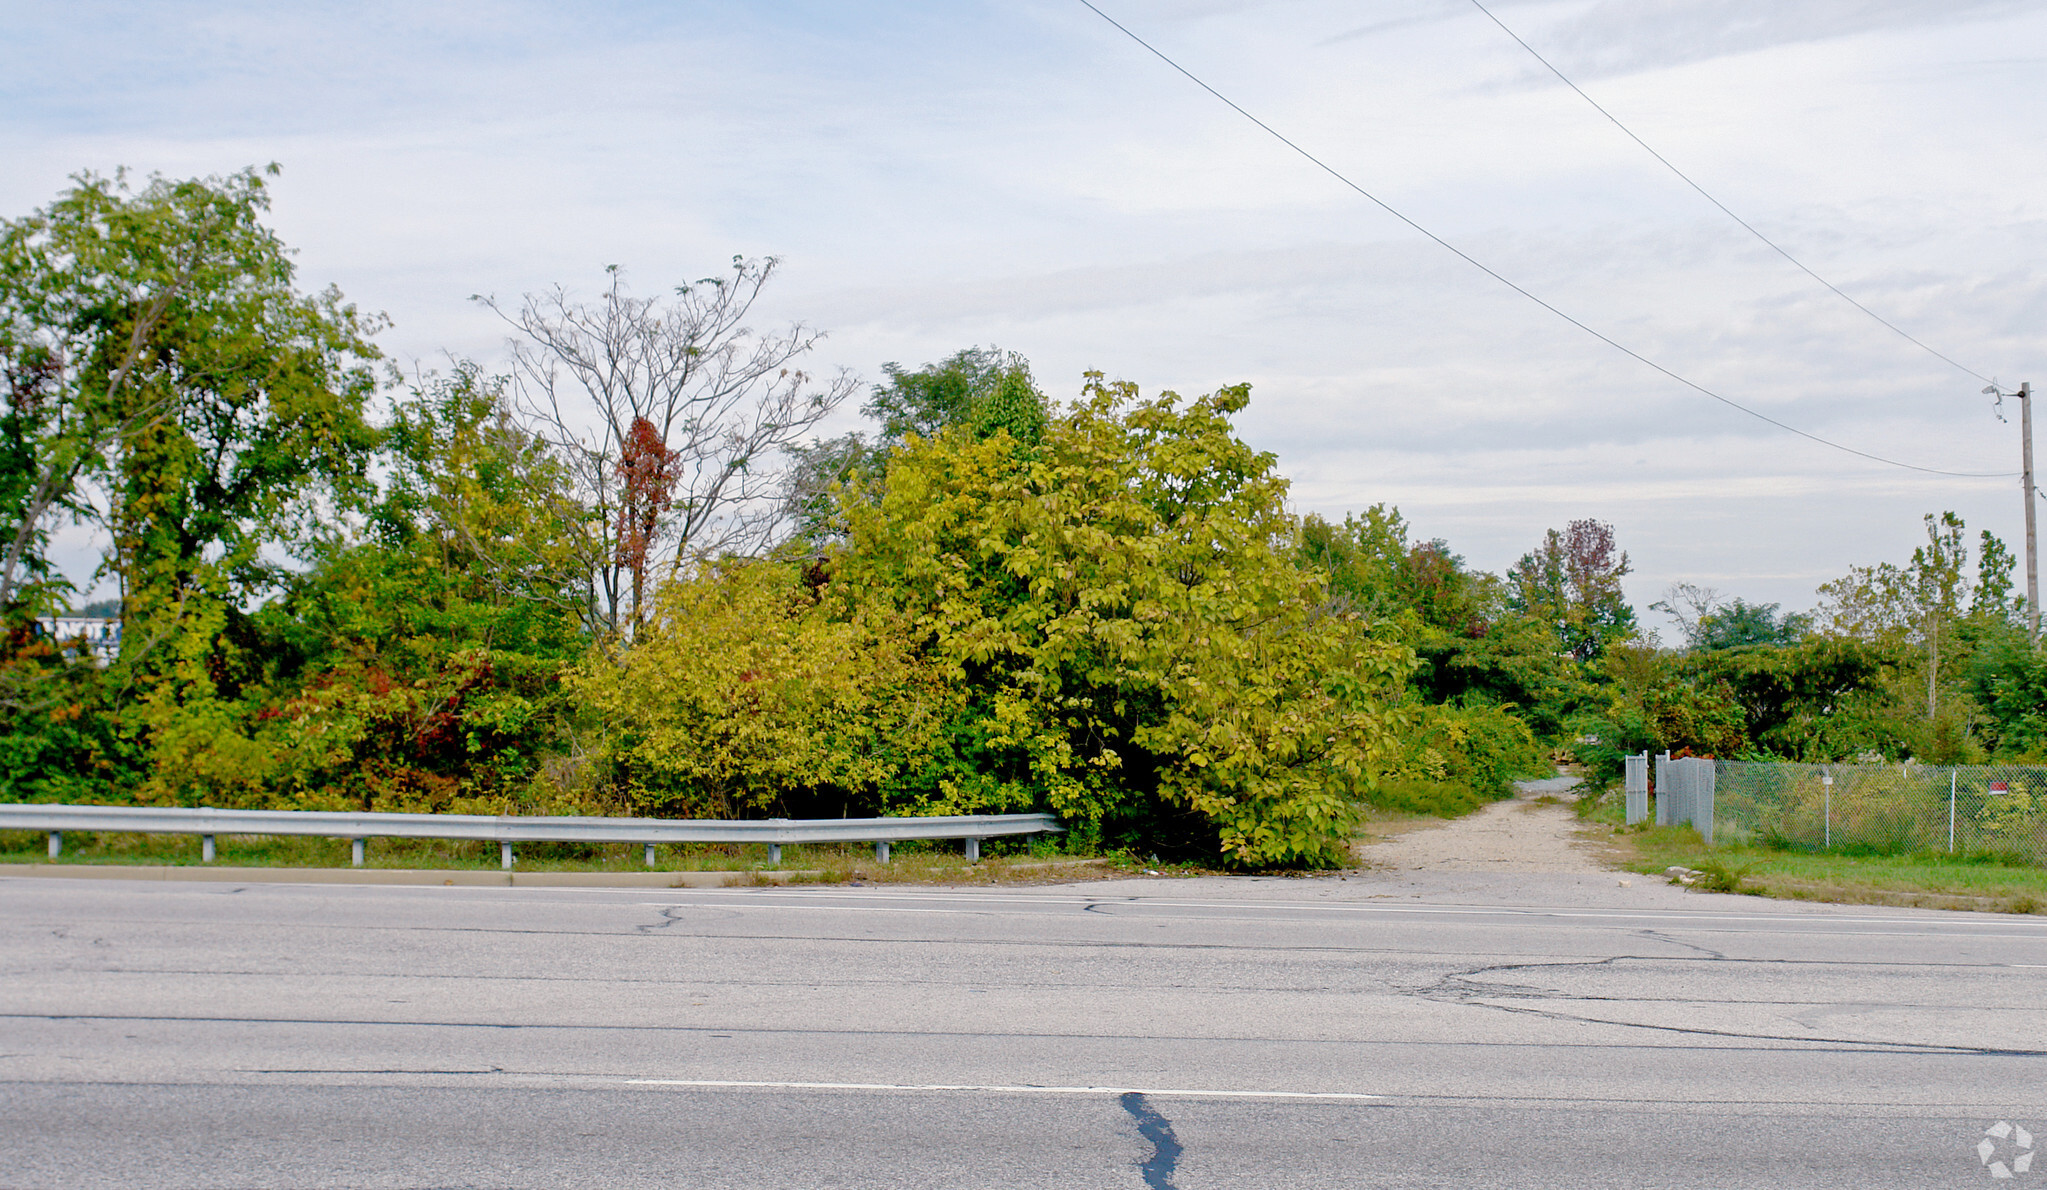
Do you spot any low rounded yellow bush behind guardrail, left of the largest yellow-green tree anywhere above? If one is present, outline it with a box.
[571,559,960,817]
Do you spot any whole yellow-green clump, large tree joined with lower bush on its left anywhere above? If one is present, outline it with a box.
[575,377,1412,864]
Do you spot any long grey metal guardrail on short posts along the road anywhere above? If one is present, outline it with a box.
[0,805,1066,868]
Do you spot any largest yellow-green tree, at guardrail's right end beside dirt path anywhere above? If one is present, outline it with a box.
[833,377,1412,864]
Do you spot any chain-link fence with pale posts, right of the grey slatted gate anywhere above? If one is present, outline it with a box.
[1711,760,2047,864]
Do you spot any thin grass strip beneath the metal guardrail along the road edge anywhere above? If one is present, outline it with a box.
[0,832,1138,883]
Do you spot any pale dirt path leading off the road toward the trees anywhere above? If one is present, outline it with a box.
[1357,776,1607,873]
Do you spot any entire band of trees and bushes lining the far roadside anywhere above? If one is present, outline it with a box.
[12,170,2047,870]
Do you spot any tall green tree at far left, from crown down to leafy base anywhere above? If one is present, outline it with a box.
[0,168,379,802]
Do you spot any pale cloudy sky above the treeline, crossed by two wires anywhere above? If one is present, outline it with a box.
[0,0,2047,623]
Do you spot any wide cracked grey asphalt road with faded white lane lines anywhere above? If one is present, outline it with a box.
[0,877,2047,1190]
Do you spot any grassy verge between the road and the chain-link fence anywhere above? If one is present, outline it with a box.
[1613,825,2047,913]
